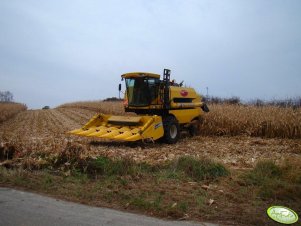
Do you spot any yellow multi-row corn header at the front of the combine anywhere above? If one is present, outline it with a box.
[69,114,164,141]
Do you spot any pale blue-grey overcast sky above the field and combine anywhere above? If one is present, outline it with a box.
[0,0,301,108]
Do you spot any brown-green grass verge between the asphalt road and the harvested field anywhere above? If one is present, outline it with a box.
[0,156,301,225]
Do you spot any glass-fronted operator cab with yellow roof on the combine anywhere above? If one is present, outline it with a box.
[121,72,160,107]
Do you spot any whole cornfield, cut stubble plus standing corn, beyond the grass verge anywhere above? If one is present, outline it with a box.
[0,101,301,169]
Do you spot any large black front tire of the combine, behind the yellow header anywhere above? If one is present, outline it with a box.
[163,116,180,144]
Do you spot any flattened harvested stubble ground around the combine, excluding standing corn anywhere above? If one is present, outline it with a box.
[0,108,301,167]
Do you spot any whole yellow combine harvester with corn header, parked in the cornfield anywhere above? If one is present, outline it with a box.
[69,69,209,144]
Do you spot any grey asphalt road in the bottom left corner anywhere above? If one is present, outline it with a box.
[0,187,217,226]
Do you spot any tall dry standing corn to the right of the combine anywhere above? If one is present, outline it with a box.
[201,104,301,138]
